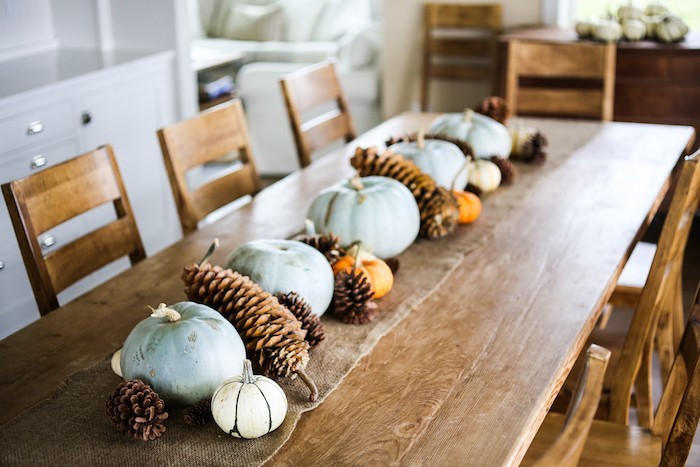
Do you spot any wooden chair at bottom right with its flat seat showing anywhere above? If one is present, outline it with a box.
[521,287,700,467]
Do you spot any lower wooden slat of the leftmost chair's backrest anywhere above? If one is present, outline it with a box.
[45,217,138,293]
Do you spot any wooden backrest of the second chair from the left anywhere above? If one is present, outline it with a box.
[158,99,260,234]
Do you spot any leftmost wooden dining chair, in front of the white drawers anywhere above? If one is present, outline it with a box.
[2,145,146,315]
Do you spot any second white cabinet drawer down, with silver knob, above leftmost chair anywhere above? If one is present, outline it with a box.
[0,140,78,183]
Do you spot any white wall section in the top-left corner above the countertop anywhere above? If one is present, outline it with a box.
[0,0,55,58]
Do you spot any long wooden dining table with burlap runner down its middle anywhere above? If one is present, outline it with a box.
[0,113,693,465]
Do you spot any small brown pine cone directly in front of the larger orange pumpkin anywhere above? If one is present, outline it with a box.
[333,270,377,324]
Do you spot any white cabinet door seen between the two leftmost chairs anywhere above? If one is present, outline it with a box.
[81,74,181,256]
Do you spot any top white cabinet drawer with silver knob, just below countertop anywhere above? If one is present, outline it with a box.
[0,100,77,154]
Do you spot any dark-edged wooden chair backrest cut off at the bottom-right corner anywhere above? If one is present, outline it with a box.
[652,287,700,466]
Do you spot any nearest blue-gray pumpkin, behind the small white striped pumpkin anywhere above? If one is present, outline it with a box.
[120,302,246,406]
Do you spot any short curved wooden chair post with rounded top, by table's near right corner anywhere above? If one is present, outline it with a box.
[535,344,610,467]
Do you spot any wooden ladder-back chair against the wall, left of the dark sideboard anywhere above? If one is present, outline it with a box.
[421,3,503,112]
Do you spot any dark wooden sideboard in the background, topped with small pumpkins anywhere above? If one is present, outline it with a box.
[498,28,700,147]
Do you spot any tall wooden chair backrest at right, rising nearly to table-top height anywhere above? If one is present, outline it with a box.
[609,150,700,424]
